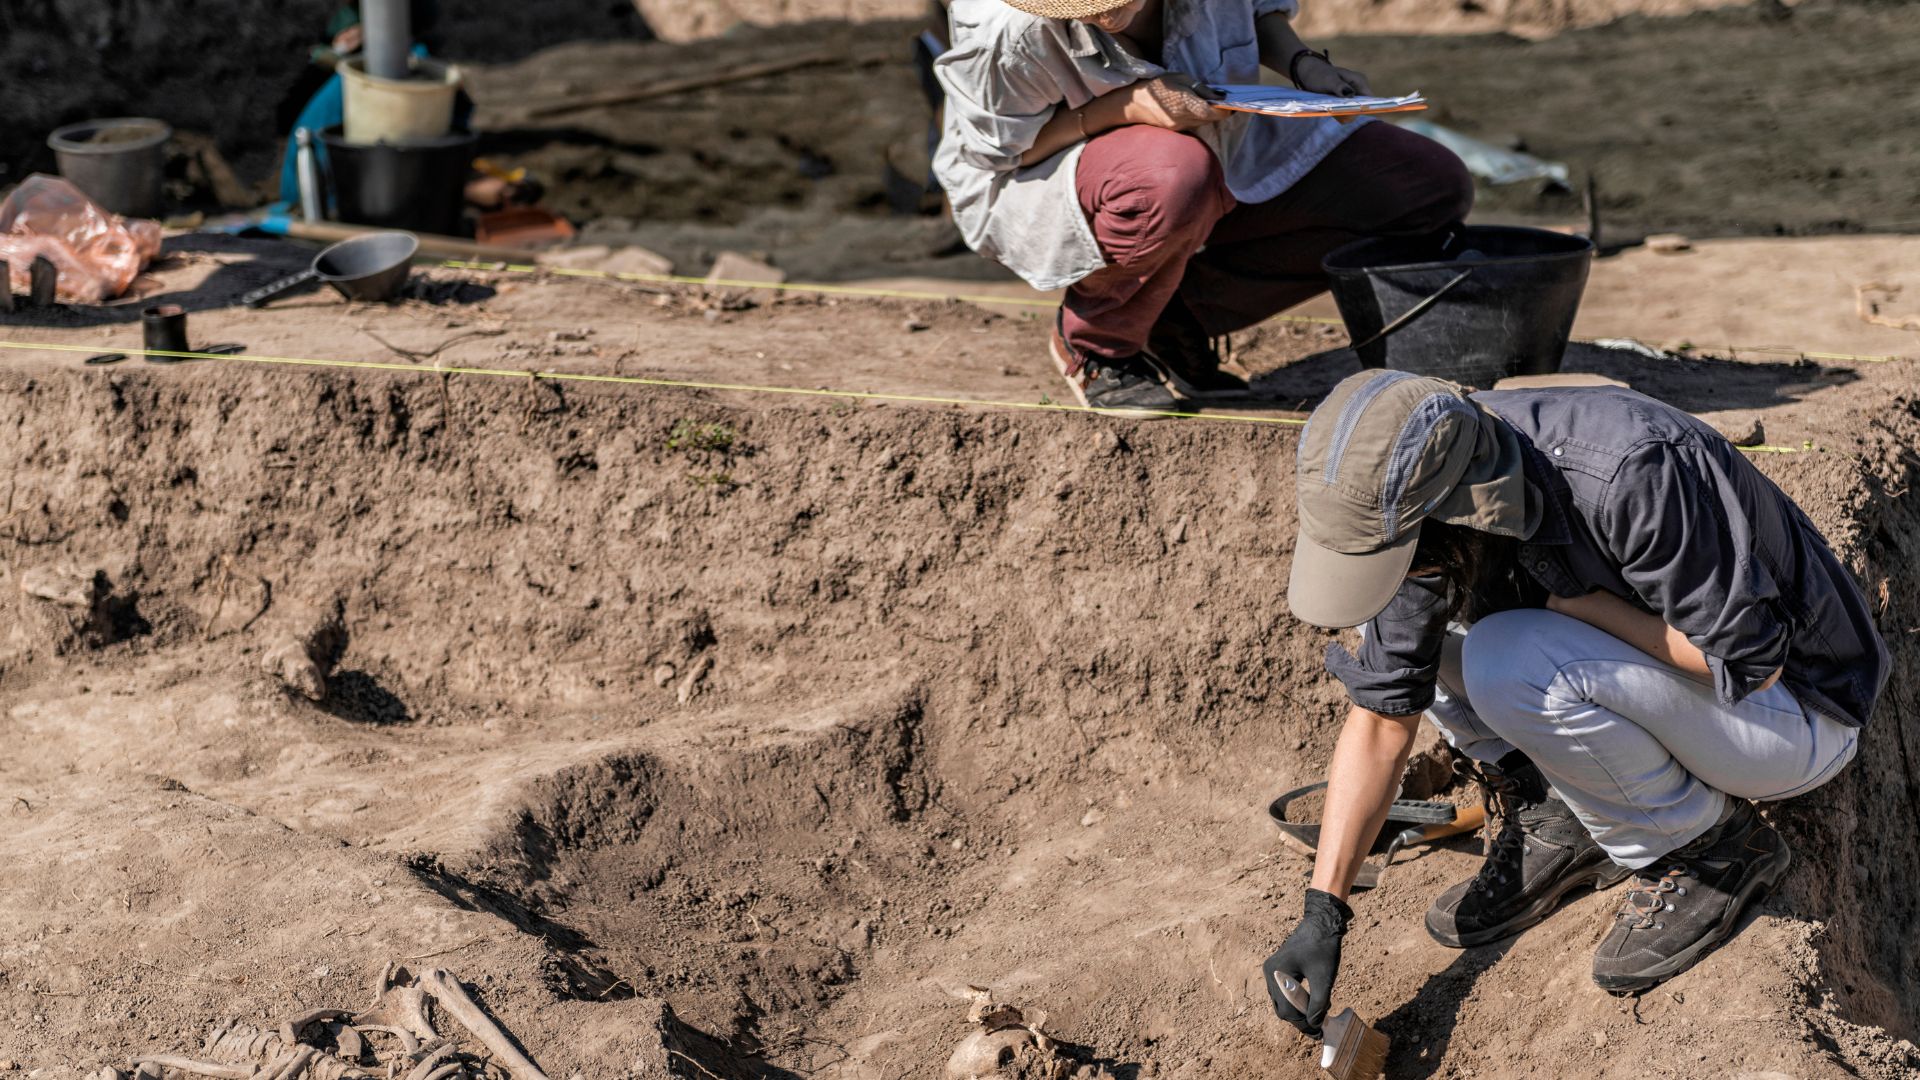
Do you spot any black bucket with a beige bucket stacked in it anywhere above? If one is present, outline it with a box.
[321,127,480,236]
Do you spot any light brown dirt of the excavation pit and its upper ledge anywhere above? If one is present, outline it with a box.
[0,246,1920,1080]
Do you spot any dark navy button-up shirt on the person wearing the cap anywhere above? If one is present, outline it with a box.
[1327,386,1891,726]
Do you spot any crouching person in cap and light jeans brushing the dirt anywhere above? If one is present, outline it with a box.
[1265,371,1889,1034]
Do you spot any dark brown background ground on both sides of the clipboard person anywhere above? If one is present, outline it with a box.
[445,0,1920,281]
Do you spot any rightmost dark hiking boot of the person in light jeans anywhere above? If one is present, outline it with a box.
[1594,799,1793,994]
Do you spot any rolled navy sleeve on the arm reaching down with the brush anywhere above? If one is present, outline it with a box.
[1327,575,1448,717]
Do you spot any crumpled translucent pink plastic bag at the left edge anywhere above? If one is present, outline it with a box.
[0,173,161,304]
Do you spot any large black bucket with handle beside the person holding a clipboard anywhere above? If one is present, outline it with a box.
[1323,225,1594,390]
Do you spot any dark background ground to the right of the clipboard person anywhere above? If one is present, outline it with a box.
[1334,2,1920,240]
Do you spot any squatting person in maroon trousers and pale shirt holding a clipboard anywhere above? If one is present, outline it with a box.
[933,0,1473,409]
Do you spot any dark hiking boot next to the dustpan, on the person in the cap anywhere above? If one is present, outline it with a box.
[1427,751,1632,949]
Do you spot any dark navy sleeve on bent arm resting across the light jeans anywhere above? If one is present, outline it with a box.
[1605,444,1791,705]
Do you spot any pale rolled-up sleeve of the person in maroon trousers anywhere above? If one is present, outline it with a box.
[935,27,1064,173]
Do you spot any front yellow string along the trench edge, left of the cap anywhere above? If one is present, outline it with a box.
[0,342,1308,427]
